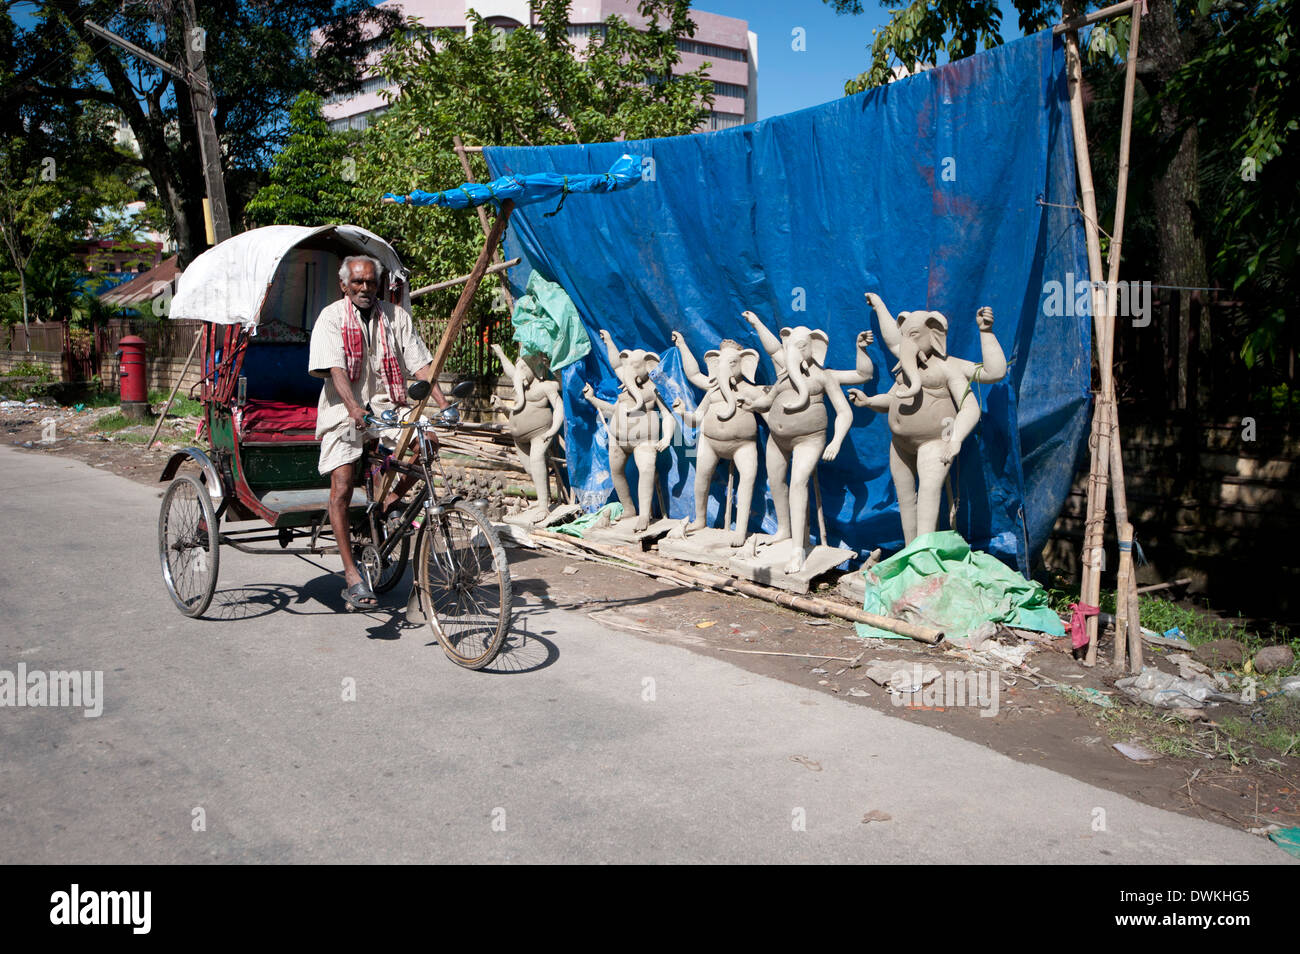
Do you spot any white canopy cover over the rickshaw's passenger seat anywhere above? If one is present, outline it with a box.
[168,225,407,328]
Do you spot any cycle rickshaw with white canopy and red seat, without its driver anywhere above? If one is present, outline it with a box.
[159,225,511,669]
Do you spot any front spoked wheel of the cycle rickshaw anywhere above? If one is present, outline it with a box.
[416,502,512,669]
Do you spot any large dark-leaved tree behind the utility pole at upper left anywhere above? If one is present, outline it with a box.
[0,0,400,266]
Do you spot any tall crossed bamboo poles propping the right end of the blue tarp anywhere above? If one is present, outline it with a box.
[1053,0,1143,672]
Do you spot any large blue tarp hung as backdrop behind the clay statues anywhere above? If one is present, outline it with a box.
[485,32,1089,568]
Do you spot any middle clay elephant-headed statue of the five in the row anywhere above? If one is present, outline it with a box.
[672,331,763,547]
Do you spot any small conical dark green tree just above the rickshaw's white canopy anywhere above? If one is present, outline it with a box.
[244,92,356,225]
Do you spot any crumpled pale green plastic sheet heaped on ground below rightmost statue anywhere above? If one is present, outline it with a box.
[855,530,1065,639]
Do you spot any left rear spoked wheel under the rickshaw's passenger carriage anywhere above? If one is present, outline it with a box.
[159,474,221,616]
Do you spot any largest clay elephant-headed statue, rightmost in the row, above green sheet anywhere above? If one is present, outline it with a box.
[849,292,1006,543]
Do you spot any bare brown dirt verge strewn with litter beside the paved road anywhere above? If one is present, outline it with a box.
[10,406,1300,847]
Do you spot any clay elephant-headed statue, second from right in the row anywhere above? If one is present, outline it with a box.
[741,312,875,573]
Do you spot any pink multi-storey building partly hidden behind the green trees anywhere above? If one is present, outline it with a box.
[324,0,758,131]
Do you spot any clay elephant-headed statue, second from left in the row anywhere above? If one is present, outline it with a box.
[582,329,676,533]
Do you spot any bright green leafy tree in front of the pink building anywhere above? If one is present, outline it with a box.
[354,0,712,371]
